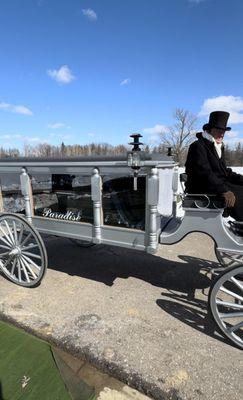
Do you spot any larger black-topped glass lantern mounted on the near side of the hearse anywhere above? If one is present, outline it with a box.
[127,133,144,190]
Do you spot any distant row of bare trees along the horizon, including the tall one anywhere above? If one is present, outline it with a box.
[0,108,243,166]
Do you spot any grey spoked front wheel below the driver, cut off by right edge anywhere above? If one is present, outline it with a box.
[209,264,243,349]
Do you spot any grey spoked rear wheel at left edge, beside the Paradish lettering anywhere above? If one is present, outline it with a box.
[0,214,47,287]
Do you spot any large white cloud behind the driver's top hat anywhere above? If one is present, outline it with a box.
[199,96,243,124]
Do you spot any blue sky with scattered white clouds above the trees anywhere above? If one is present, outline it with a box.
[0,0,243,148]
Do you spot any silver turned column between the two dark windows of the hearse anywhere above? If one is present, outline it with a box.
[91,168,103,243]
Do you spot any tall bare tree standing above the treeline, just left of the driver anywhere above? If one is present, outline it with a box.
[161,108,197,165]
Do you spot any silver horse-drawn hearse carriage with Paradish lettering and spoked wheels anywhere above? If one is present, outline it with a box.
[0,134,243,348]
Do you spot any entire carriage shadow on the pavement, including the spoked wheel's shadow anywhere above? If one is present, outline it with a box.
[26,237,232,343]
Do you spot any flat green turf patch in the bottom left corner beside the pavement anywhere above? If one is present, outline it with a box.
[0,321,93,400]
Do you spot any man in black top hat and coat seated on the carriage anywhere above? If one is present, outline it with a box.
[185,111,243,221]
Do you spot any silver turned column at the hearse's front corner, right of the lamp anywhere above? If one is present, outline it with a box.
[147,168,159,254]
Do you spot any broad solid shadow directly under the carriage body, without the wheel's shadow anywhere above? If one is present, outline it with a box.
[45,234,218,290]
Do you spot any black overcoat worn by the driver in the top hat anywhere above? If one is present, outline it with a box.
[185,133,243,194]
